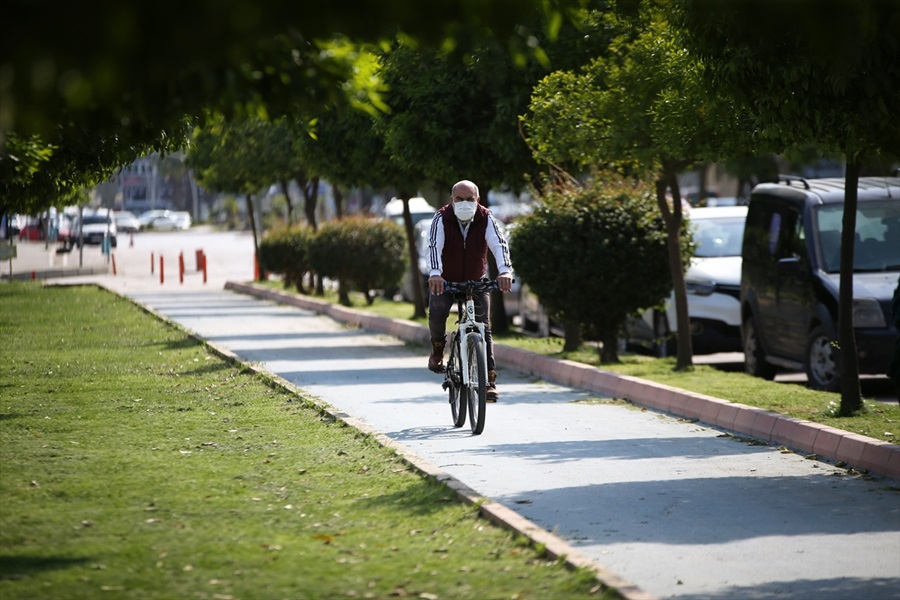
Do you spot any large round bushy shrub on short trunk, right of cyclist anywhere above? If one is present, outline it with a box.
[511,182,684,362]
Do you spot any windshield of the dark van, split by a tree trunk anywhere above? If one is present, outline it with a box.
[816,198,900,273]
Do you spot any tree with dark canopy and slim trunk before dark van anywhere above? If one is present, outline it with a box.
[671,0,900,416]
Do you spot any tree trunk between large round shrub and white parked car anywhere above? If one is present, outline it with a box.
[656,171,694,371]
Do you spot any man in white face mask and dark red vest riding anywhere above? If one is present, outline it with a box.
[428,180,513,402]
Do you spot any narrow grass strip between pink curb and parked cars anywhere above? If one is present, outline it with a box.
[260,281,900,443]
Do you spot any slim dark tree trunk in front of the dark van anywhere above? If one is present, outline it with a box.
[838,155,862,417]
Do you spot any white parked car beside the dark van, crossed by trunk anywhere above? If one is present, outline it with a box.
[626,206,747,356]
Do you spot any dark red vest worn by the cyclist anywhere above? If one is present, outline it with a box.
[439,203,490,281]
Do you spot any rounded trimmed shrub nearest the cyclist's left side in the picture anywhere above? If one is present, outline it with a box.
[310,217,409,306]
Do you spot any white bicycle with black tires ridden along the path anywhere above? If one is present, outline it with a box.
[443,279,499,435]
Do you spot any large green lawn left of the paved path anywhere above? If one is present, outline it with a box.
[0,282,618,600]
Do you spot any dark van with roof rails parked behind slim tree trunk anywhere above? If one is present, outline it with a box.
[741,177,900,391]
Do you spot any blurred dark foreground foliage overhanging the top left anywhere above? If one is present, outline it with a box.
[0,0,579,138]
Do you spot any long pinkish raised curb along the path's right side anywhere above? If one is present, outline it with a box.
[225,281,900,479]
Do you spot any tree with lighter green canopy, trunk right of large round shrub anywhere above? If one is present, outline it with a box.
[526,7,741,370]
